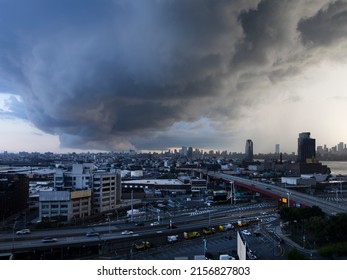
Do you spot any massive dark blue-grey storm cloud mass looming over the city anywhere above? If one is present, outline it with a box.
[0,0,343,149]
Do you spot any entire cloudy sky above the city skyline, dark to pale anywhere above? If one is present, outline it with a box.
[0,0,347,153]
